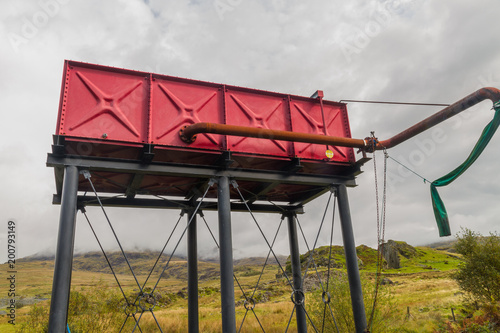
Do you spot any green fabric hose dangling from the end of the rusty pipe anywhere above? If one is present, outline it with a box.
[431,101,500,237]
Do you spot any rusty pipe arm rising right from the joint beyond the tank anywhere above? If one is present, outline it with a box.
[376,87,500,150]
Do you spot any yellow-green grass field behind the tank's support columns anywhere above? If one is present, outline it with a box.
[0,241,462,332]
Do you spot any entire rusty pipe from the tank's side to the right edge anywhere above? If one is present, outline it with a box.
[179,88,500,152]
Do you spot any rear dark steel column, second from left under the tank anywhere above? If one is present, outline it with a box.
[187,210,199,333]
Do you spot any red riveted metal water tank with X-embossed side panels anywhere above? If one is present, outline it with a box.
[56,61,355,174]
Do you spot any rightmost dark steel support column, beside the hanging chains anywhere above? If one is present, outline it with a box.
[337,184,367,333]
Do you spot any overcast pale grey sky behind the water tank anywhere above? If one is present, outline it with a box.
[0,0,500,261]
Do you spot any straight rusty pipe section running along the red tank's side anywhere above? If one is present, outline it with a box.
[179,123,366,148]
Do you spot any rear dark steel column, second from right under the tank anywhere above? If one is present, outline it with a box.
[285,212,307,333]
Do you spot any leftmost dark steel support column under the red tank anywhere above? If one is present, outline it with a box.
[49,166,78,333]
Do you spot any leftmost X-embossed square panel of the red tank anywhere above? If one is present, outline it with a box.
[57,65,149,143]
